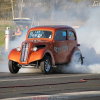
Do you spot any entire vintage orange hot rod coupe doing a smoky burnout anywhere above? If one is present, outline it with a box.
[8,25,83,74]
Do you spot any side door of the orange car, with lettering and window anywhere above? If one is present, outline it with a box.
[53,30,69,64]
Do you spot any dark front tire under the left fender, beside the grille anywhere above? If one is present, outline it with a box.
[8,60,19,74]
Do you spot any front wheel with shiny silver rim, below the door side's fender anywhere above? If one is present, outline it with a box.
[40,56,52,74]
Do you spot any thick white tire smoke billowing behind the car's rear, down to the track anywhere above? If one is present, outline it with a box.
[62,7,100,73]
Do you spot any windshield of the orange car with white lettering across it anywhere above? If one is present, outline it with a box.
[28,31,52,39]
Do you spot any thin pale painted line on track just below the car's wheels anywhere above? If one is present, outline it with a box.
[0,74,93,82]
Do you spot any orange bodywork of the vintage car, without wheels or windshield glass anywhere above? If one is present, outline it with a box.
[8,26,79,65]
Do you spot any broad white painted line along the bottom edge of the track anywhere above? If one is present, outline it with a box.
[1,91,100,100]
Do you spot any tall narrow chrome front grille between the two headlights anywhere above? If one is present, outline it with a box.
[21,43,29,62]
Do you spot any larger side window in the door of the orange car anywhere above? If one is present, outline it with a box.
[55,31,67,41]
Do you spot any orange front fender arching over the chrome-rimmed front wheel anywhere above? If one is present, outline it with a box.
[29,49,55,65]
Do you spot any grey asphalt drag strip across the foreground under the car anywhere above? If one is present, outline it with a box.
[0,73,100,100]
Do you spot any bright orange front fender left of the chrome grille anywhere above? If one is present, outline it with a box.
[8,49,21,62]
